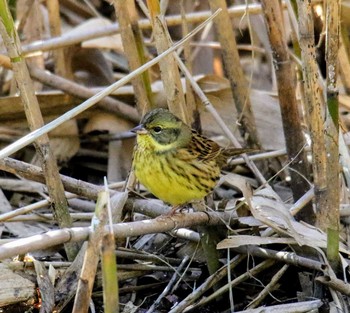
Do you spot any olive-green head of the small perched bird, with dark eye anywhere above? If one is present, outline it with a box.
[132,108,191,152]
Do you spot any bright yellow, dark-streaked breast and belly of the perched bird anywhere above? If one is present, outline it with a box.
[133,136,220,205]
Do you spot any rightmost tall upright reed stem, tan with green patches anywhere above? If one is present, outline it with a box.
[324,0,341,271]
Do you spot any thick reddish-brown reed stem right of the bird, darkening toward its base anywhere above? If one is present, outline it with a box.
[262,0,315,224]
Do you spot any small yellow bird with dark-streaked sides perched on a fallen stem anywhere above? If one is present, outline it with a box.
[131,108,252,215]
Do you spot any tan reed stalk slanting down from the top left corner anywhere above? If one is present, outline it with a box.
[0,0,78,260]
